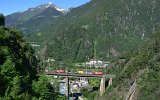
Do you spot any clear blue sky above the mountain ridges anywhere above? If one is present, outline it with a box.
[0,0,90,15]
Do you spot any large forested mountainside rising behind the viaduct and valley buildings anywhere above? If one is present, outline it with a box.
[5,0,160,62]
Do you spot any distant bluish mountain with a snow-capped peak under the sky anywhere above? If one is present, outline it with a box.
[6,2,69,34]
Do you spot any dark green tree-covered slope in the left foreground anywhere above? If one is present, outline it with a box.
[0,15,57,100]
